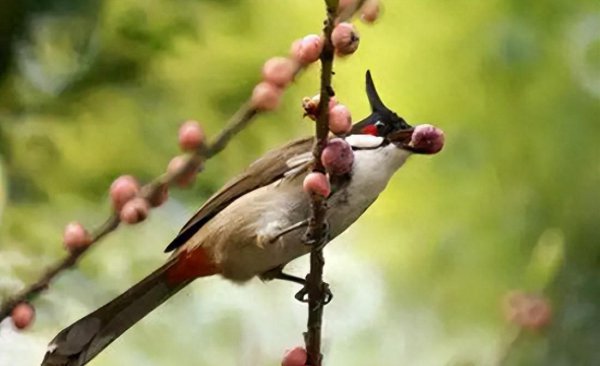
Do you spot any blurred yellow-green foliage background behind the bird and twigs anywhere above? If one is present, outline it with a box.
[0,0,600,365]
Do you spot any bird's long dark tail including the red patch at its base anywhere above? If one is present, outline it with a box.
[42,247,215,366]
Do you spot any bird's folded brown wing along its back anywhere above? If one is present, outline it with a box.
[165,137,314,252]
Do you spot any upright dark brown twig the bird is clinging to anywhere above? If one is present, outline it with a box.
[304,0,338,366]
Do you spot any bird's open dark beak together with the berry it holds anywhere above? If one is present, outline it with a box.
[387,125,444,154]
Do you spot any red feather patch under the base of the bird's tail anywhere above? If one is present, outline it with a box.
[167,247,219,285]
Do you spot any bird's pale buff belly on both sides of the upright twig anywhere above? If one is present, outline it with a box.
[195,169,383,282]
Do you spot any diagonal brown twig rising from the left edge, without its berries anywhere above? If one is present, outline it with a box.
[0,103,259,321]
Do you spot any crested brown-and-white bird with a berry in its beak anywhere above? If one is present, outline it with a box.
[42,71,444,366]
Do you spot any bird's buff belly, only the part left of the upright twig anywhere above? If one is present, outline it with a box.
[200,178,310,282]
